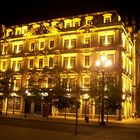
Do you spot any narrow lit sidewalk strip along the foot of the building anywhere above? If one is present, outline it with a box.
[0,112,140,125]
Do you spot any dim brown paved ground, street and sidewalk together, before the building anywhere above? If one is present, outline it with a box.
[0,115,140,140]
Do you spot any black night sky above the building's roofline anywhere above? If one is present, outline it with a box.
[0,0,140,26]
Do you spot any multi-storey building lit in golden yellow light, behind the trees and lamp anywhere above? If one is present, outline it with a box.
[0,10,136,118]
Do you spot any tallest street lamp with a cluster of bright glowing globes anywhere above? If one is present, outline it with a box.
[95,55,111,125]
